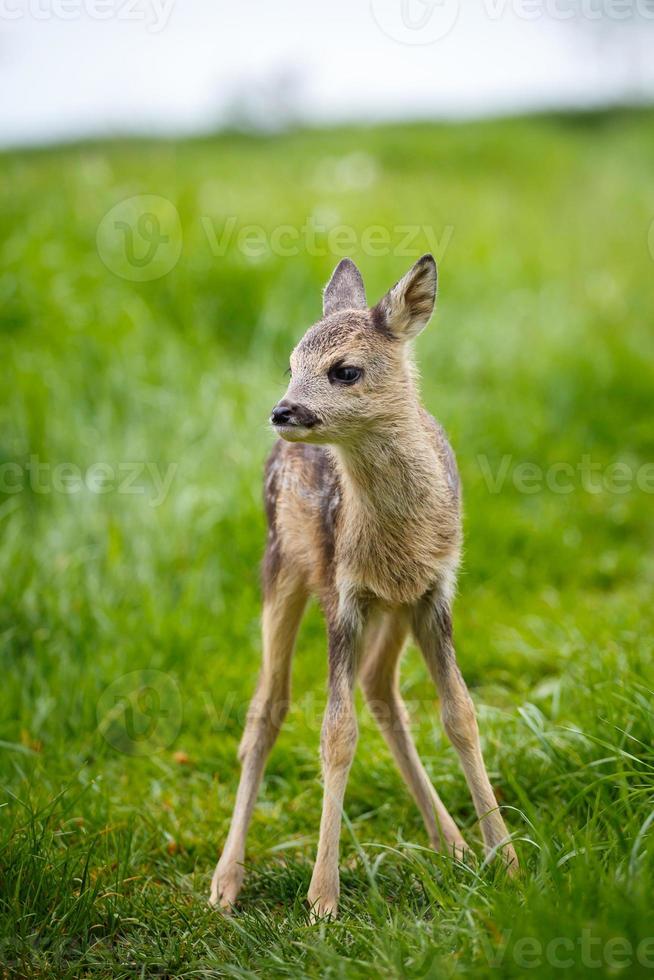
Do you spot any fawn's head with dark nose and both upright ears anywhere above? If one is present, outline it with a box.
[270,255,437,443]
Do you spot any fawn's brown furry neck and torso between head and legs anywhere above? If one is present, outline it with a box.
[263,411,461,603]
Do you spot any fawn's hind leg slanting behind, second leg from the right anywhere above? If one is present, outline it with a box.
[361,611,465,857]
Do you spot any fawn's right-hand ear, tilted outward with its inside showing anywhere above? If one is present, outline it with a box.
[372,255,438,340]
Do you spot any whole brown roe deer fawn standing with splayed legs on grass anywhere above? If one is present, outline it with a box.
[210,255,517,918]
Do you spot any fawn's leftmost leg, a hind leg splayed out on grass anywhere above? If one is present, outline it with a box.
[209,566,307,908]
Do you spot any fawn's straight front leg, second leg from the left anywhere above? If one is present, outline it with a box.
[308,598,364,918]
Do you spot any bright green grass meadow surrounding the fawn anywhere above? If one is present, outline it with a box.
[0,112,654,978]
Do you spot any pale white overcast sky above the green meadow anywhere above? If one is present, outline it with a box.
[0,0,654,144]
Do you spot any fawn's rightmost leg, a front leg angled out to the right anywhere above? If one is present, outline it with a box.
[413,593,518,873]
